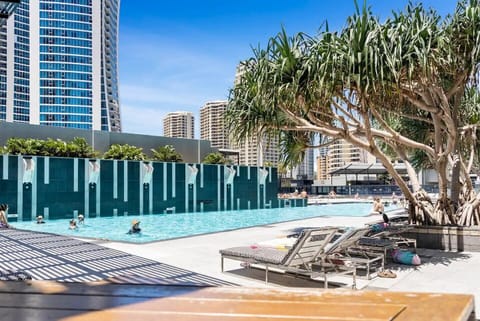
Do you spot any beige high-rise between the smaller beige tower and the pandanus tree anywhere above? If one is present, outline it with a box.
[200,100,230,148]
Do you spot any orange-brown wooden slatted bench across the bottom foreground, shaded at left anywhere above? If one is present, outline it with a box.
[0,281,475,321]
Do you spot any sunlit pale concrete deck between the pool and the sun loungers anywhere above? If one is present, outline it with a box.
[86,212,480,311]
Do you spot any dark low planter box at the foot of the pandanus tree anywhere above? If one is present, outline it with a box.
[404,226,480,252]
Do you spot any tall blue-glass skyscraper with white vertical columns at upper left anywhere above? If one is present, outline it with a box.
[0,0,121,132]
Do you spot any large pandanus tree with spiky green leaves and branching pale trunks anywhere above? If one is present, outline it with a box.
[226,0,480,225]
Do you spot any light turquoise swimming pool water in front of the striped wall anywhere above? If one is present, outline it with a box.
[12,203,386,243]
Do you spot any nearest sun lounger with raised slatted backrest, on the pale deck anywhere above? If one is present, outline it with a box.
[220,227,356,287]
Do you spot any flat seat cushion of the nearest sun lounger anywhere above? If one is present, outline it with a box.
[220,246,288,264]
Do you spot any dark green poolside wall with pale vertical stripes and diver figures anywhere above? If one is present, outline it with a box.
[0,155,288,220]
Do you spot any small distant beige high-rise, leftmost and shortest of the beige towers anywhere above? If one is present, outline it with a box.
[163,111,195,139]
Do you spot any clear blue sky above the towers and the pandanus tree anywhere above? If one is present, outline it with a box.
[119,0,456,138]
